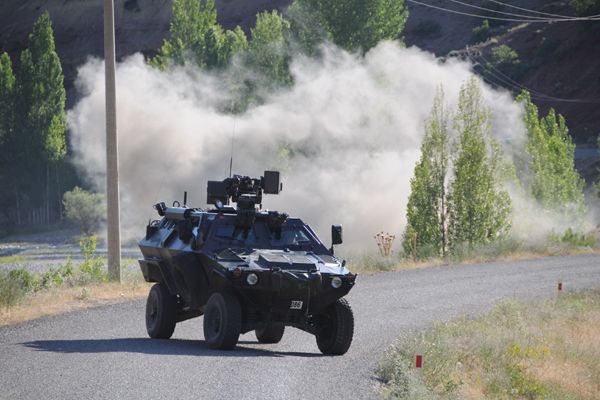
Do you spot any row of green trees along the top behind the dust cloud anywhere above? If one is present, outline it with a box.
[149,0,408,113]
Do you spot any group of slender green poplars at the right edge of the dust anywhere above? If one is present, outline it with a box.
[402,78,588,259]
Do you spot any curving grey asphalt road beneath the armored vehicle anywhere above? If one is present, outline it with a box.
[0,255,600,400]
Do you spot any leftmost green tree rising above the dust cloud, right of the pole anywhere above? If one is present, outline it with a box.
[150,0,247,69]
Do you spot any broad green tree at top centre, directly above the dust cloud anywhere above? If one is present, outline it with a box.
[296,0,408,52]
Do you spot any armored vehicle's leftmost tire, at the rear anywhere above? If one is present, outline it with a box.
[146,283,177,339]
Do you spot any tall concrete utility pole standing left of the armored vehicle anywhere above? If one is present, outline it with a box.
[104,0,121,282]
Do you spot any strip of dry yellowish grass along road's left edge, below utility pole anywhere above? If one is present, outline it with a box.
[0,282,150,326]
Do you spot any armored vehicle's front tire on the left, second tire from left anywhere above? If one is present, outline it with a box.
[204,292,242,350]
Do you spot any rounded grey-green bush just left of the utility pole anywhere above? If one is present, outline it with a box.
[63,186,106,236]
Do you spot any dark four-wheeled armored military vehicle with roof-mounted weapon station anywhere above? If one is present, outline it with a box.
[139,171,356,355]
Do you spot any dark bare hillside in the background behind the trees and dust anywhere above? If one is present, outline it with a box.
[0,0,600,148]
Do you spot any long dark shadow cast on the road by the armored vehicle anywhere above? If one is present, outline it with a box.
[21,338,323,357]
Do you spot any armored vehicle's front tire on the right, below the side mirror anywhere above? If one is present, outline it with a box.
[315,299,354,355]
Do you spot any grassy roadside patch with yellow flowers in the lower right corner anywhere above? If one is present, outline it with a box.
[377,290,600,399]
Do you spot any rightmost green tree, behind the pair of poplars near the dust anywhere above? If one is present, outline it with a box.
[517,91,585,214]
